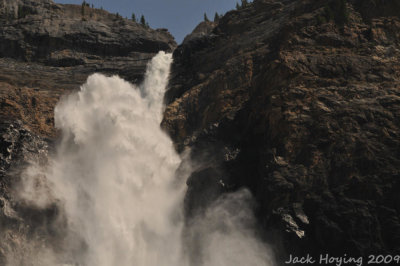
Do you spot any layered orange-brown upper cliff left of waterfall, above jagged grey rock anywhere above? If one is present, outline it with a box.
[0,0,176,136]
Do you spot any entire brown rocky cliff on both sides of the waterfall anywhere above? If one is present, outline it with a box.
[0,0,400,265]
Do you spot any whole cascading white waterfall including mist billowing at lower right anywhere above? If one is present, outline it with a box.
[10,52,272,266]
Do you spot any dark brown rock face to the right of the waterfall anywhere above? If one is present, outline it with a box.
[162,0,400,264]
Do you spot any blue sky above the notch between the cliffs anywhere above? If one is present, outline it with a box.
[55,0,240,44]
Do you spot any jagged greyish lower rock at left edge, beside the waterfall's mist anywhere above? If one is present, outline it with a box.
[0,121,60,265]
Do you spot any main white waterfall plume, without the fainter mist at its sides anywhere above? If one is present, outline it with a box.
[50,53,184,266]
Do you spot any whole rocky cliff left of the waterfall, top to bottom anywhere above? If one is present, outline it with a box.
[0,0,176,265]
